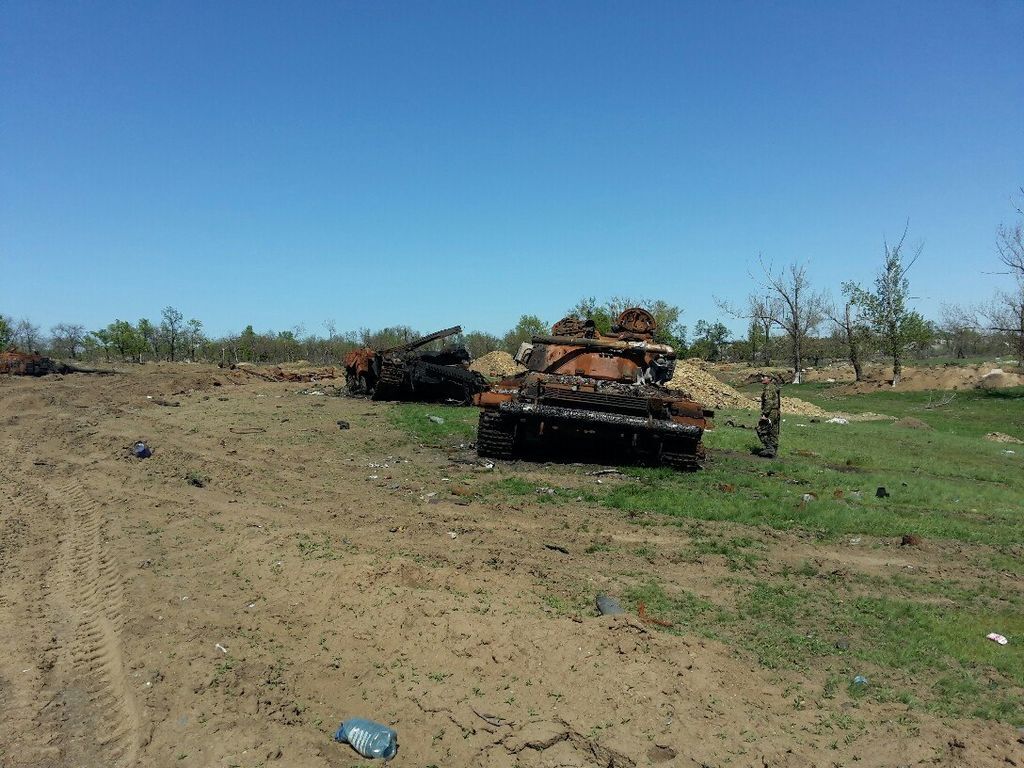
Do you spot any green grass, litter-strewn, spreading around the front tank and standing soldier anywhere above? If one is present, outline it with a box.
[392,385,1024,726]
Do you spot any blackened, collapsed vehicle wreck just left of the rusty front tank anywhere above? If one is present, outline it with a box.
[344,326,487,404]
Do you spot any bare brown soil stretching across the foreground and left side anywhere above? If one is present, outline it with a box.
[0,366,1024,768]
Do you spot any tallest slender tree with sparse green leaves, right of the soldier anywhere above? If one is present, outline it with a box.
[849,227,924,387]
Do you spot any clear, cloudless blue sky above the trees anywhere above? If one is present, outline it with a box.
[0,0,1024,334]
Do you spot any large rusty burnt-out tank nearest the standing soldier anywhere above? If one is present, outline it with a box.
[473,308,714,470]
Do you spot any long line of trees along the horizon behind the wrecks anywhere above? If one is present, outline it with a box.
[0,196,1024,384]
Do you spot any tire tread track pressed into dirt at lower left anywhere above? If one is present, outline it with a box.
[0,450,140,768]
